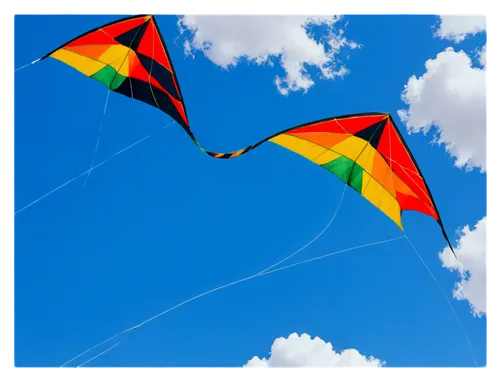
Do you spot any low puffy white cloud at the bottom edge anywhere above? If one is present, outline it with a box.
[243,333,384,369]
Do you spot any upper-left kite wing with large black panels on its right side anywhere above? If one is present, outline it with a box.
[42,14,191,135]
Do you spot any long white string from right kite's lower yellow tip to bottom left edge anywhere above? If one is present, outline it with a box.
[71,236,404,369]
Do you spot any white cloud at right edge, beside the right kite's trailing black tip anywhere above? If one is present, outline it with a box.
[439,217,488,317]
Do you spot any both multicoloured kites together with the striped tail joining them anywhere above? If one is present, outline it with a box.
[23,13,455,255]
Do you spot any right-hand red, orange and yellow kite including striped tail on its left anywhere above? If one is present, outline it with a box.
[207,113,453,251]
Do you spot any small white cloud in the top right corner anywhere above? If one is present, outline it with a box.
[435,9,488,43]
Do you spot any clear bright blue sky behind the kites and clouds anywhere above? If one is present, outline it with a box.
[13,14,488,369]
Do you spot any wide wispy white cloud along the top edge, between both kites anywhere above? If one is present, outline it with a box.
[179,13,359,95]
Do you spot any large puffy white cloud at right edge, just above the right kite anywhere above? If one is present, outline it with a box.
[398,47,488,172]
